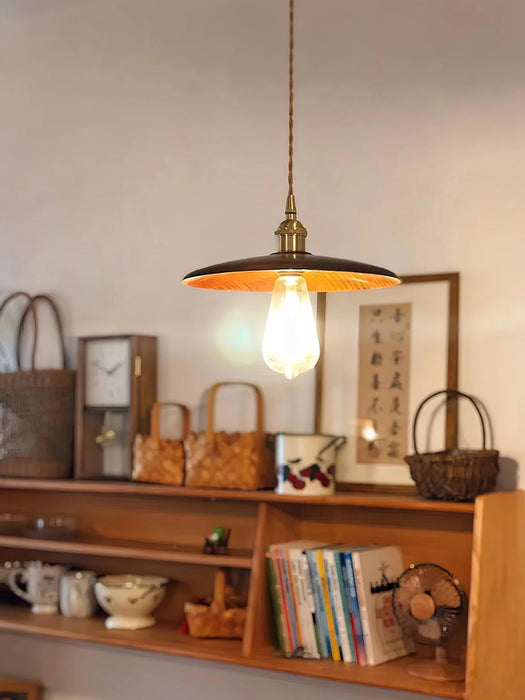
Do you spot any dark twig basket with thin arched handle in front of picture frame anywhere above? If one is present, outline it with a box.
[405,389,499,501]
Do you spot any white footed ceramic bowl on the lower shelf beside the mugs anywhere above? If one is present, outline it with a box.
[95,574,168,630]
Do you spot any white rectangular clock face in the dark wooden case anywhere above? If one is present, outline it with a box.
[86,338,131,406]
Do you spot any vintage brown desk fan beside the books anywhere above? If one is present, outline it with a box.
[393,564,468,681]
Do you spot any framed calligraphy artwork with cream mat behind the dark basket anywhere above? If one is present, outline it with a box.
[315,273,459,490]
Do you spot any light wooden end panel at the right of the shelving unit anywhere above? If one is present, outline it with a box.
[466,491,525,700]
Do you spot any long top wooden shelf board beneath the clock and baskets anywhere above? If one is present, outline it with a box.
[0,478,474,513]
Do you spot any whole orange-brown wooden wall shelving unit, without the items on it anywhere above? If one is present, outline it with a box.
[0,479,525,700]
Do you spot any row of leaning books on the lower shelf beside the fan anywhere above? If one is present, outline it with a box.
[266,540,414,666]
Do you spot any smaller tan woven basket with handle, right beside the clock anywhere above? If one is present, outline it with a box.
[131,402,190,486]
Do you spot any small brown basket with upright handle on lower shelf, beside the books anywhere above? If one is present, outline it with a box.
[184,570,246,639]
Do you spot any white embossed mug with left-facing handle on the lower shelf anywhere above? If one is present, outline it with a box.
[8,561,67,615]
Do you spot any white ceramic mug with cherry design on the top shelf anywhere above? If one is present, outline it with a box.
[275,433,346,496]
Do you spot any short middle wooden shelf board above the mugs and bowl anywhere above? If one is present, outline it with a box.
[0,535,252,569]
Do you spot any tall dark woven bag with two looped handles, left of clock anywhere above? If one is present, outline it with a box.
[0,292,75,479]
